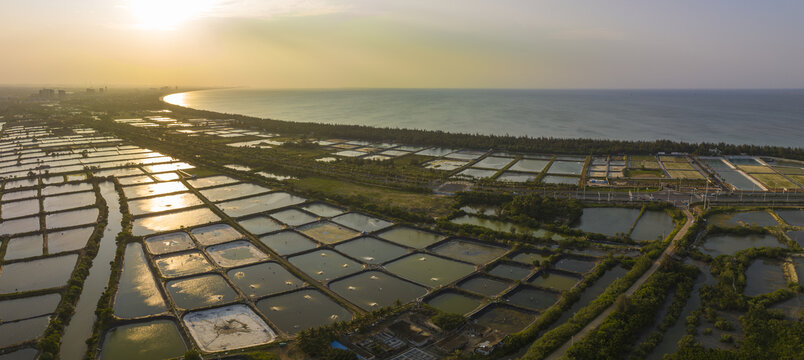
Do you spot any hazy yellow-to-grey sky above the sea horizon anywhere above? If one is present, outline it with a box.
[0,0,804,88]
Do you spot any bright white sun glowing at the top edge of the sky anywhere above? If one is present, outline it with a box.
[128,0,216,30]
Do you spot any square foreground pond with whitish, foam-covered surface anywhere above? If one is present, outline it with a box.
[184,304,276,352]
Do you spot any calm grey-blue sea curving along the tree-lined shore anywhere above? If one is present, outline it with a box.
[165,88,804,147]
